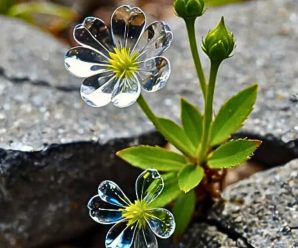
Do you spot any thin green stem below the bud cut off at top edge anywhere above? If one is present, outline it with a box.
[185,18,206,99]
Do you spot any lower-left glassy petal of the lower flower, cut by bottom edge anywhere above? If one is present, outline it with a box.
[106,222,136,248]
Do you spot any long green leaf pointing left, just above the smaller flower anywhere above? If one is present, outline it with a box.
[116,146,187,171]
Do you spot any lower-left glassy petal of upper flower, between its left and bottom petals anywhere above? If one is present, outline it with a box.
[81,73,117,107]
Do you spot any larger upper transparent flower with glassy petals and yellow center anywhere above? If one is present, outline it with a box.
[65,5,173,108]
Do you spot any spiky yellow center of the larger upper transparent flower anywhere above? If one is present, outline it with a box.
[109,48,138,78]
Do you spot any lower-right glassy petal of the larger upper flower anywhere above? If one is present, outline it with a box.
[138,57,171,92]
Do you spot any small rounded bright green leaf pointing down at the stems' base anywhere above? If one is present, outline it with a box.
[178,165,204,193]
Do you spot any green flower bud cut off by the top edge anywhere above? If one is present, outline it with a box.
[174,0,205,19]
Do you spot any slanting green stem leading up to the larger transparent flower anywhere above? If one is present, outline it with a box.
[137,95,194,158]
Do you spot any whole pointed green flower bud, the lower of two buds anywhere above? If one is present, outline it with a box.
[203,17,235,62]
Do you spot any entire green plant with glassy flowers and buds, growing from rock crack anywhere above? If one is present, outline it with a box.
[65,0,261,248]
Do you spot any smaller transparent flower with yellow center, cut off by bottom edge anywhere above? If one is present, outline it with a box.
[88,169,175,248]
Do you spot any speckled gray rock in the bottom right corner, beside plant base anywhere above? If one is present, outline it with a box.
[180,160,298,248]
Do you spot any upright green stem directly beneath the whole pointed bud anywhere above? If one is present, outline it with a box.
[198,62,220,163]
